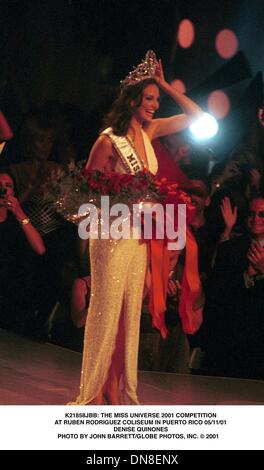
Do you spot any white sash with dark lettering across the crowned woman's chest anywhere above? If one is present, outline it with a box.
[102,127,144,175]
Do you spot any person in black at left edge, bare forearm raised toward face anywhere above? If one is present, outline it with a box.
[0,169,45,329]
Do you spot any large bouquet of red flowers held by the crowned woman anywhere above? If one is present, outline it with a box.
[42,162,191,224]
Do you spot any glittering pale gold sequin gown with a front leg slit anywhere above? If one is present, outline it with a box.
[70,131,158,405]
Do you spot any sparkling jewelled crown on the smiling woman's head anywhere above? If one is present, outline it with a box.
[121,51,159,89]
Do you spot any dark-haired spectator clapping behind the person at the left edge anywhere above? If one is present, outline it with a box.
[10,111,76,338]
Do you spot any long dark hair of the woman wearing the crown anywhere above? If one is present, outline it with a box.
[102,78,158,135]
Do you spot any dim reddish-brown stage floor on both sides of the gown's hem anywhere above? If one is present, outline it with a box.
[0,329,264,405]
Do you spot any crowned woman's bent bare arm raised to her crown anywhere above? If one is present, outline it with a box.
[147,61,203,139]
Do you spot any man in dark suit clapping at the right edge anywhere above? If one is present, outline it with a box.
[201,195,264,379]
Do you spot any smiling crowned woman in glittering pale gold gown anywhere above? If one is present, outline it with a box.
[71,52,201,405]
